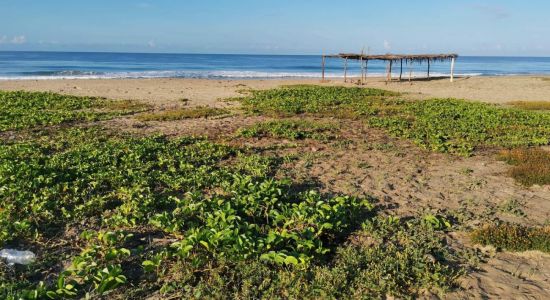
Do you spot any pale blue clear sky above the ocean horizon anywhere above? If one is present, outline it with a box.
[0,0,550,56]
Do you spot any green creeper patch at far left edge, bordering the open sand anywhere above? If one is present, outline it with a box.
[0,91,147,132]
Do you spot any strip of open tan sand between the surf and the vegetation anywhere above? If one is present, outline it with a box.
[0,76,550,107]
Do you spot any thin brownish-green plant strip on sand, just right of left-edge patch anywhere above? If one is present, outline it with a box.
[137,106,229,121]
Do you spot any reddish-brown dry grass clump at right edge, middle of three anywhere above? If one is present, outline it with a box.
[500,148,550,186]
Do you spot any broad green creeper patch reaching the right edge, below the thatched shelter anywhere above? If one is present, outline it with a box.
[370,99,550,155]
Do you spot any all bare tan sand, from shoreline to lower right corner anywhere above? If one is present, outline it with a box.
[0,76,550,299]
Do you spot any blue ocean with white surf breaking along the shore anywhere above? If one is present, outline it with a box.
[0,51,550,80]
